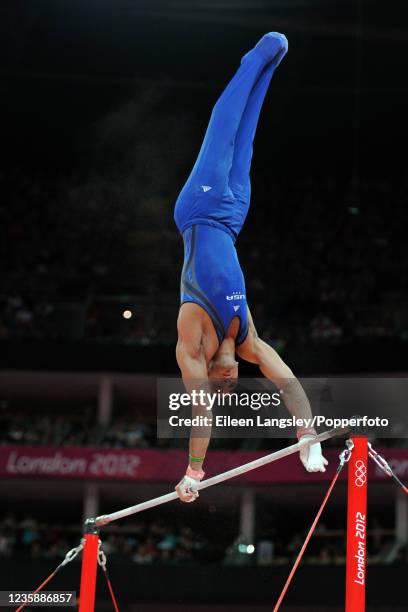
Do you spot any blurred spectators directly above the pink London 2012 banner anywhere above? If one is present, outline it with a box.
[0,399,408,451]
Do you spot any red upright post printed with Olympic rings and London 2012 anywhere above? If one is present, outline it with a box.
[345,435,368,612]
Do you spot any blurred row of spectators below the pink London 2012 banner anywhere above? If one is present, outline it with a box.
[0,513,408,566]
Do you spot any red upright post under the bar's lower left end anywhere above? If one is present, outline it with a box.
[79,519,99,612]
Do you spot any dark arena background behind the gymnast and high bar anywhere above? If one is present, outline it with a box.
[0,0,408,612]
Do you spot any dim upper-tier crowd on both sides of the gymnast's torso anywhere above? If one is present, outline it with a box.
[0,167,408,344]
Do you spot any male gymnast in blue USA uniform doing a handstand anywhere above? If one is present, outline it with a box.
[174,32,327,502]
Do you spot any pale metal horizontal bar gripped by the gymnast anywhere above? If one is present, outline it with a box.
[95,427,349,527]
